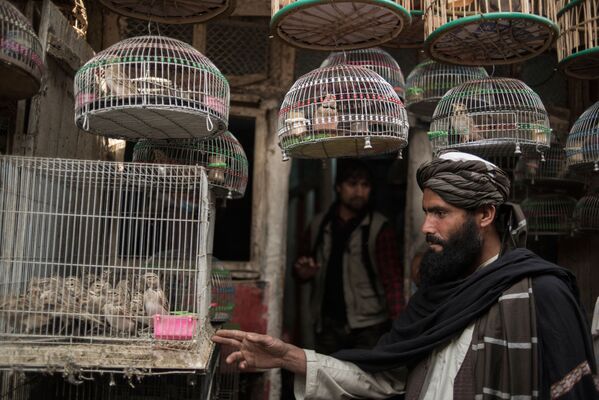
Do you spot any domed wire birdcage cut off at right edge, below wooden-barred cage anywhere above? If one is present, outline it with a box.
[566,101,599,172]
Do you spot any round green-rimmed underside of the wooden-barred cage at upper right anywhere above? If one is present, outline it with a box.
[425,13,558,66]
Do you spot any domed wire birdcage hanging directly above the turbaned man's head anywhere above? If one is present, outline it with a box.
[429,78,551,156]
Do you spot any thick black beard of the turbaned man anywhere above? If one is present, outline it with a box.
[420,216,482,287]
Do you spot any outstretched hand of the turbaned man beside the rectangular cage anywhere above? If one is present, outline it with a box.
[212,329,306,375]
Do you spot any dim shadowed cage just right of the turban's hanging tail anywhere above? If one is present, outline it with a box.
[520,194,576,236]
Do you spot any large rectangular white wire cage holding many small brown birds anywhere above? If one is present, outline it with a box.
[0,156,211,370]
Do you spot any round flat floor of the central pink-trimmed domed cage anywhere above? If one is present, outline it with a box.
[287,136,407,158]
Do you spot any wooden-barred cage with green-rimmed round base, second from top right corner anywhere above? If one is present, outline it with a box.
[424,0,559,65]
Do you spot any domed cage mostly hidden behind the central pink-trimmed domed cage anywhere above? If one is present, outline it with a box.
[320,48,406,101]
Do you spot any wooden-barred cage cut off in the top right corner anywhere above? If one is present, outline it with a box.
[557,0,599,79]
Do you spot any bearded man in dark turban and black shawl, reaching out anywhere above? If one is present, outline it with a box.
[213,152,599,400]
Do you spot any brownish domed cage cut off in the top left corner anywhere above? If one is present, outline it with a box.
[0,0,44,100]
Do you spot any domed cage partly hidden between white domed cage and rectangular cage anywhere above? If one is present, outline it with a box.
[133,131,249,199]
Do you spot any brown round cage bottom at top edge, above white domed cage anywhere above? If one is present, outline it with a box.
[100,0,236,24]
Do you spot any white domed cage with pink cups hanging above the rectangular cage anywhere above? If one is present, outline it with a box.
[75,36,229,140]
